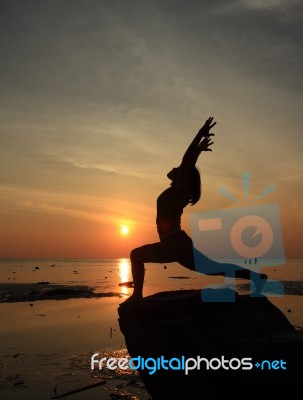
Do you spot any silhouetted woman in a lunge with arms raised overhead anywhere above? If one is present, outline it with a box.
[121,117,267,306]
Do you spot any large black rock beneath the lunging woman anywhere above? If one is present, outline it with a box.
[118,290,303,400]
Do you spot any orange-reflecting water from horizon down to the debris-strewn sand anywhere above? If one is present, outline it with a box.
[0,259,303,353]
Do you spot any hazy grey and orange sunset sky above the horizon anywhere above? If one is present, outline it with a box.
[0,0,303,258]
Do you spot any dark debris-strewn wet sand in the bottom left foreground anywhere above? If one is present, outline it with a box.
[0,350,150,400]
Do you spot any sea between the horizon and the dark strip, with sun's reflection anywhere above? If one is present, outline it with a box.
[0,258,303,295]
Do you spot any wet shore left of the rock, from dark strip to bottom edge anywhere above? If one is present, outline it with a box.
[0,297,149,400]
